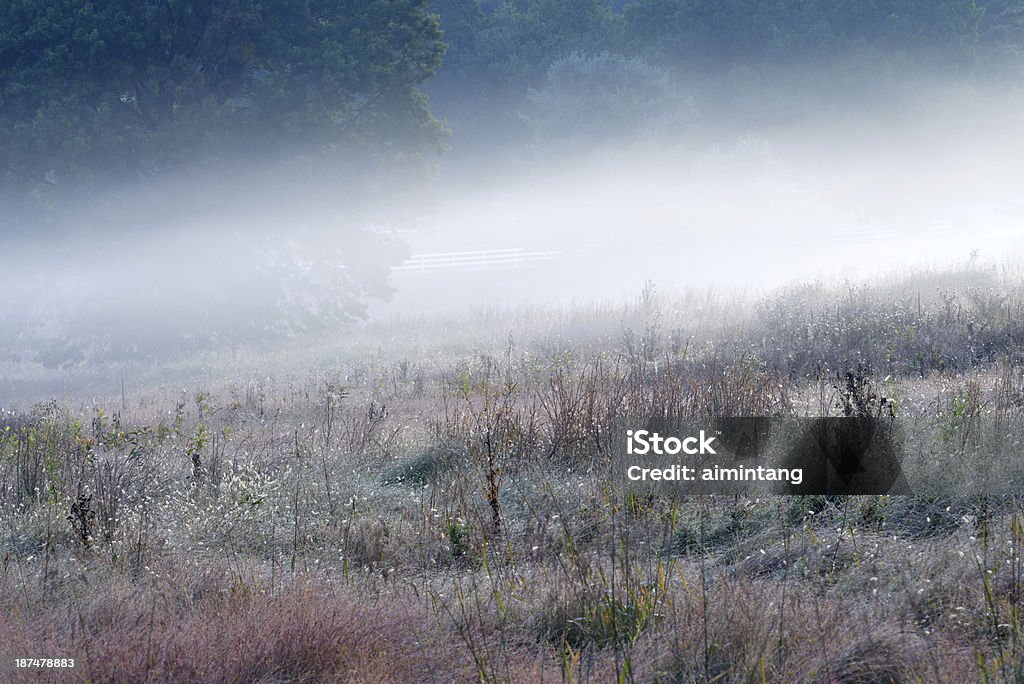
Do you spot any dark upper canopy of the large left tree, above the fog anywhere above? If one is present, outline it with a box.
[0,0,444,196]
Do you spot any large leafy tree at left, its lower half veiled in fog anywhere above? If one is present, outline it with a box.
[0,0,445,360]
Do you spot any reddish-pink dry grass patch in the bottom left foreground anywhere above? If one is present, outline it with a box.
[0,578,473,682]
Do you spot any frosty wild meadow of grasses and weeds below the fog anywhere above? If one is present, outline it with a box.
[0,263,1024,683]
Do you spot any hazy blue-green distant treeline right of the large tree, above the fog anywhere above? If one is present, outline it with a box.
[427,0,1024,157]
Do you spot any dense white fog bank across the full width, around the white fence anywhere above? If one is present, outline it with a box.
[0,77,1024,366]
